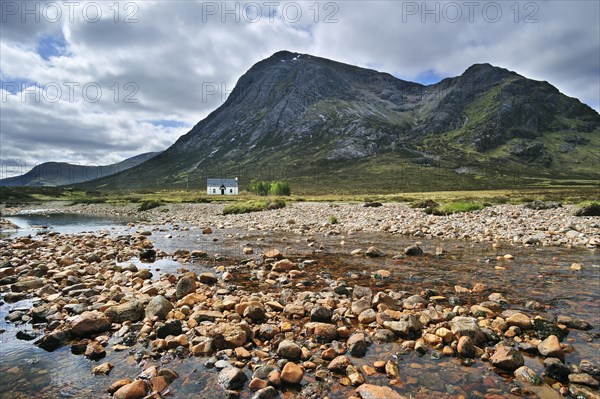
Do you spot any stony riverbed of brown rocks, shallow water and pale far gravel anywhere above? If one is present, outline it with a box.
[0,209,600,399]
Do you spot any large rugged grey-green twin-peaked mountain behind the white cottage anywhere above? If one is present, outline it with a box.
[82,51,600,192]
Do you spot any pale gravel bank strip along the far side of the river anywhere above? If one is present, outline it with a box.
[2,202,600,249]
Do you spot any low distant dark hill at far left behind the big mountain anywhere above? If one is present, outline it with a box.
[0,152,160,186]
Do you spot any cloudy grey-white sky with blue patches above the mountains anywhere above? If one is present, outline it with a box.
[0,0,600,177]
